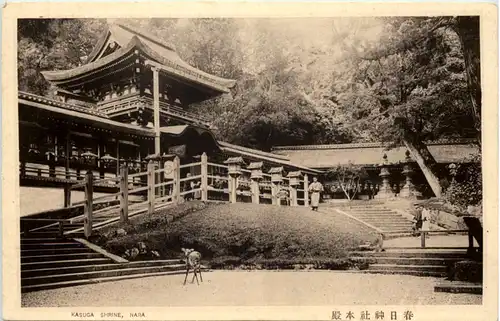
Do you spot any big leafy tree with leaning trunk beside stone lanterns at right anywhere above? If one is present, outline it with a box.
[341,18,477,197]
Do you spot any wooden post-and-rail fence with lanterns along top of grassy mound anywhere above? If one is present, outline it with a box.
[21,153,309,237]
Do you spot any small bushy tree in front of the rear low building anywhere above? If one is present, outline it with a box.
[327,162,368,201]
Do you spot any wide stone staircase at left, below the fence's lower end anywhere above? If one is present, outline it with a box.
[21,235,191,292]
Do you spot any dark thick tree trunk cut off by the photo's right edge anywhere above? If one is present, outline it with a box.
[454,16,481,142]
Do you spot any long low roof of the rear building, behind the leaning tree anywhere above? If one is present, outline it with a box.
[272,139,480,169]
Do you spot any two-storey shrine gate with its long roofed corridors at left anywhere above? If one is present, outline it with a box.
[18,22,321,212]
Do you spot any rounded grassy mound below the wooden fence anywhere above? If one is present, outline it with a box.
[95,202,376,269]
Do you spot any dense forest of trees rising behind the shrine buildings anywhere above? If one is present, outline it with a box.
[18,17,481,195]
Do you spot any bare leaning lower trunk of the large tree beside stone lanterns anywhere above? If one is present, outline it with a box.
[403,139,442,197]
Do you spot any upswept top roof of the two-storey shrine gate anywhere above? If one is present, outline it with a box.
[42,23,236,93]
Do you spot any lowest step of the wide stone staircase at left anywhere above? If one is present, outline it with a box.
[21,270,196,293]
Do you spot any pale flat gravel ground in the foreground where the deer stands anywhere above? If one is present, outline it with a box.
[22,271,482,307]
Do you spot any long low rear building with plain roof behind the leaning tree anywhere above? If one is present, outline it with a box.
[272,139,480,199]
